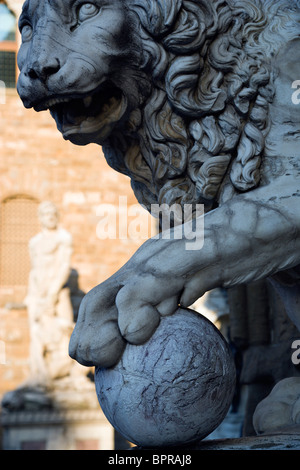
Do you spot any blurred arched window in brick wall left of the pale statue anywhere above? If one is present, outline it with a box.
[0,196,39,287]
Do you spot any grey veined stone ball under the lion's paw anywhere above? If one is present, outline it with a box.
[95,308,236,448]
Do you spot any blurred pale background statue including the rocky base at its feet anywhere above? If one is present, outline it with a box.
[2,201,98,409]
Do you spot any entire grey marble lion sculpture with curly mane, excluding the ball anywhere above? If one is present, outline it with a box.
[18,0,300,444]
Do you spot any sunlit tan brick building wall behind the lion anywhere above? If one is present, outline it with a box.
[0,0,150,448]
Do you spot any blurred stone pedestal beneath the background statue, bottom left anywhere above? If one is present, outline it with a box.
[1,410,114,450]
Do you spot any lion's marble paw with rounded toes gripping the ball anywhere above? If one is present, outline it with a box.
[69,278,178,367]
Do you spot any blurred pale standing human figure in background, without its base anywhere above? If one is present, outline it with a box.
[25,201,73,383]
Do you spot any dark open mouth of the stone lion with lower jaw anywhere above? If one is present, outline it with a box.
[39,83,127,145]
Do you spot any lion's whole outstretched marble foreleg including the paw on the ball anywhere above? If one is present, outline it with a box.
[71,176,300,367]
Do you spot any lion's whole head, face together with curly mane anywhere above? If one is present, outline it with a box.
[18,0,297,210]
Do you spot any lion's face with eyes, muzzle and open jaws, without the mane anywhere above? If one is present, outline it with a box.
[17,0,150,145]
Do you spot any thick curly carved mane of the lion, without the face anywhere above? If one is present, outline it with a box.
[104,0,299,214]
